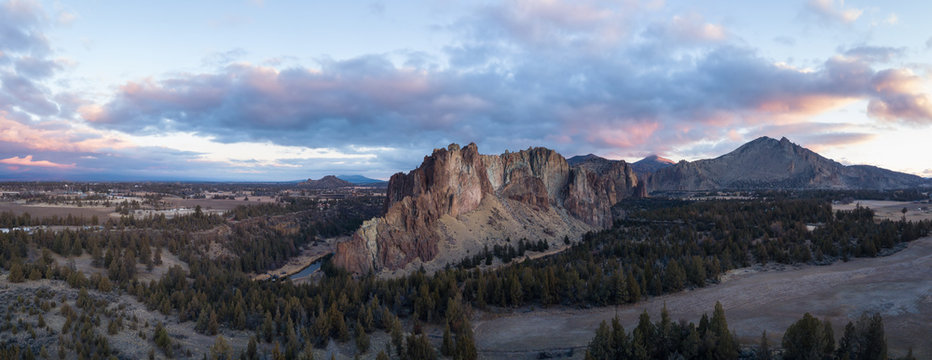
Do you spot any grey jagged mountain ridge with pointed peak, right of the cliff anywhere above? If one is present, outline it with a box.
[646,137,926,191]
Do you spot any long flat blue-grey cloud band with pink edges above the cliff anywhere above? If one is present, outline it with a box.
[81,40,932,167]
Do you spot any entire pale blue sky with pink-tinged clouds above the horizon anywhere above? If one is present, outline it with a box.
[0,0,932,181]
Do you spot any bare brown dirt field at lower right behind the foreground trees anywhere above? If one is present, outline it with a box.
[473,238,932,359]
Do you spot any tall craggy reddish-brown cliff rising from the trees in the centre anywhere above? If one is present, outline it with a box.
[334,144,638,273]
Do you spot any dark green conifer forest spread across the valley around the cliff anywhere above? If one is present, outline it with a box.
[0,198,932,359]
